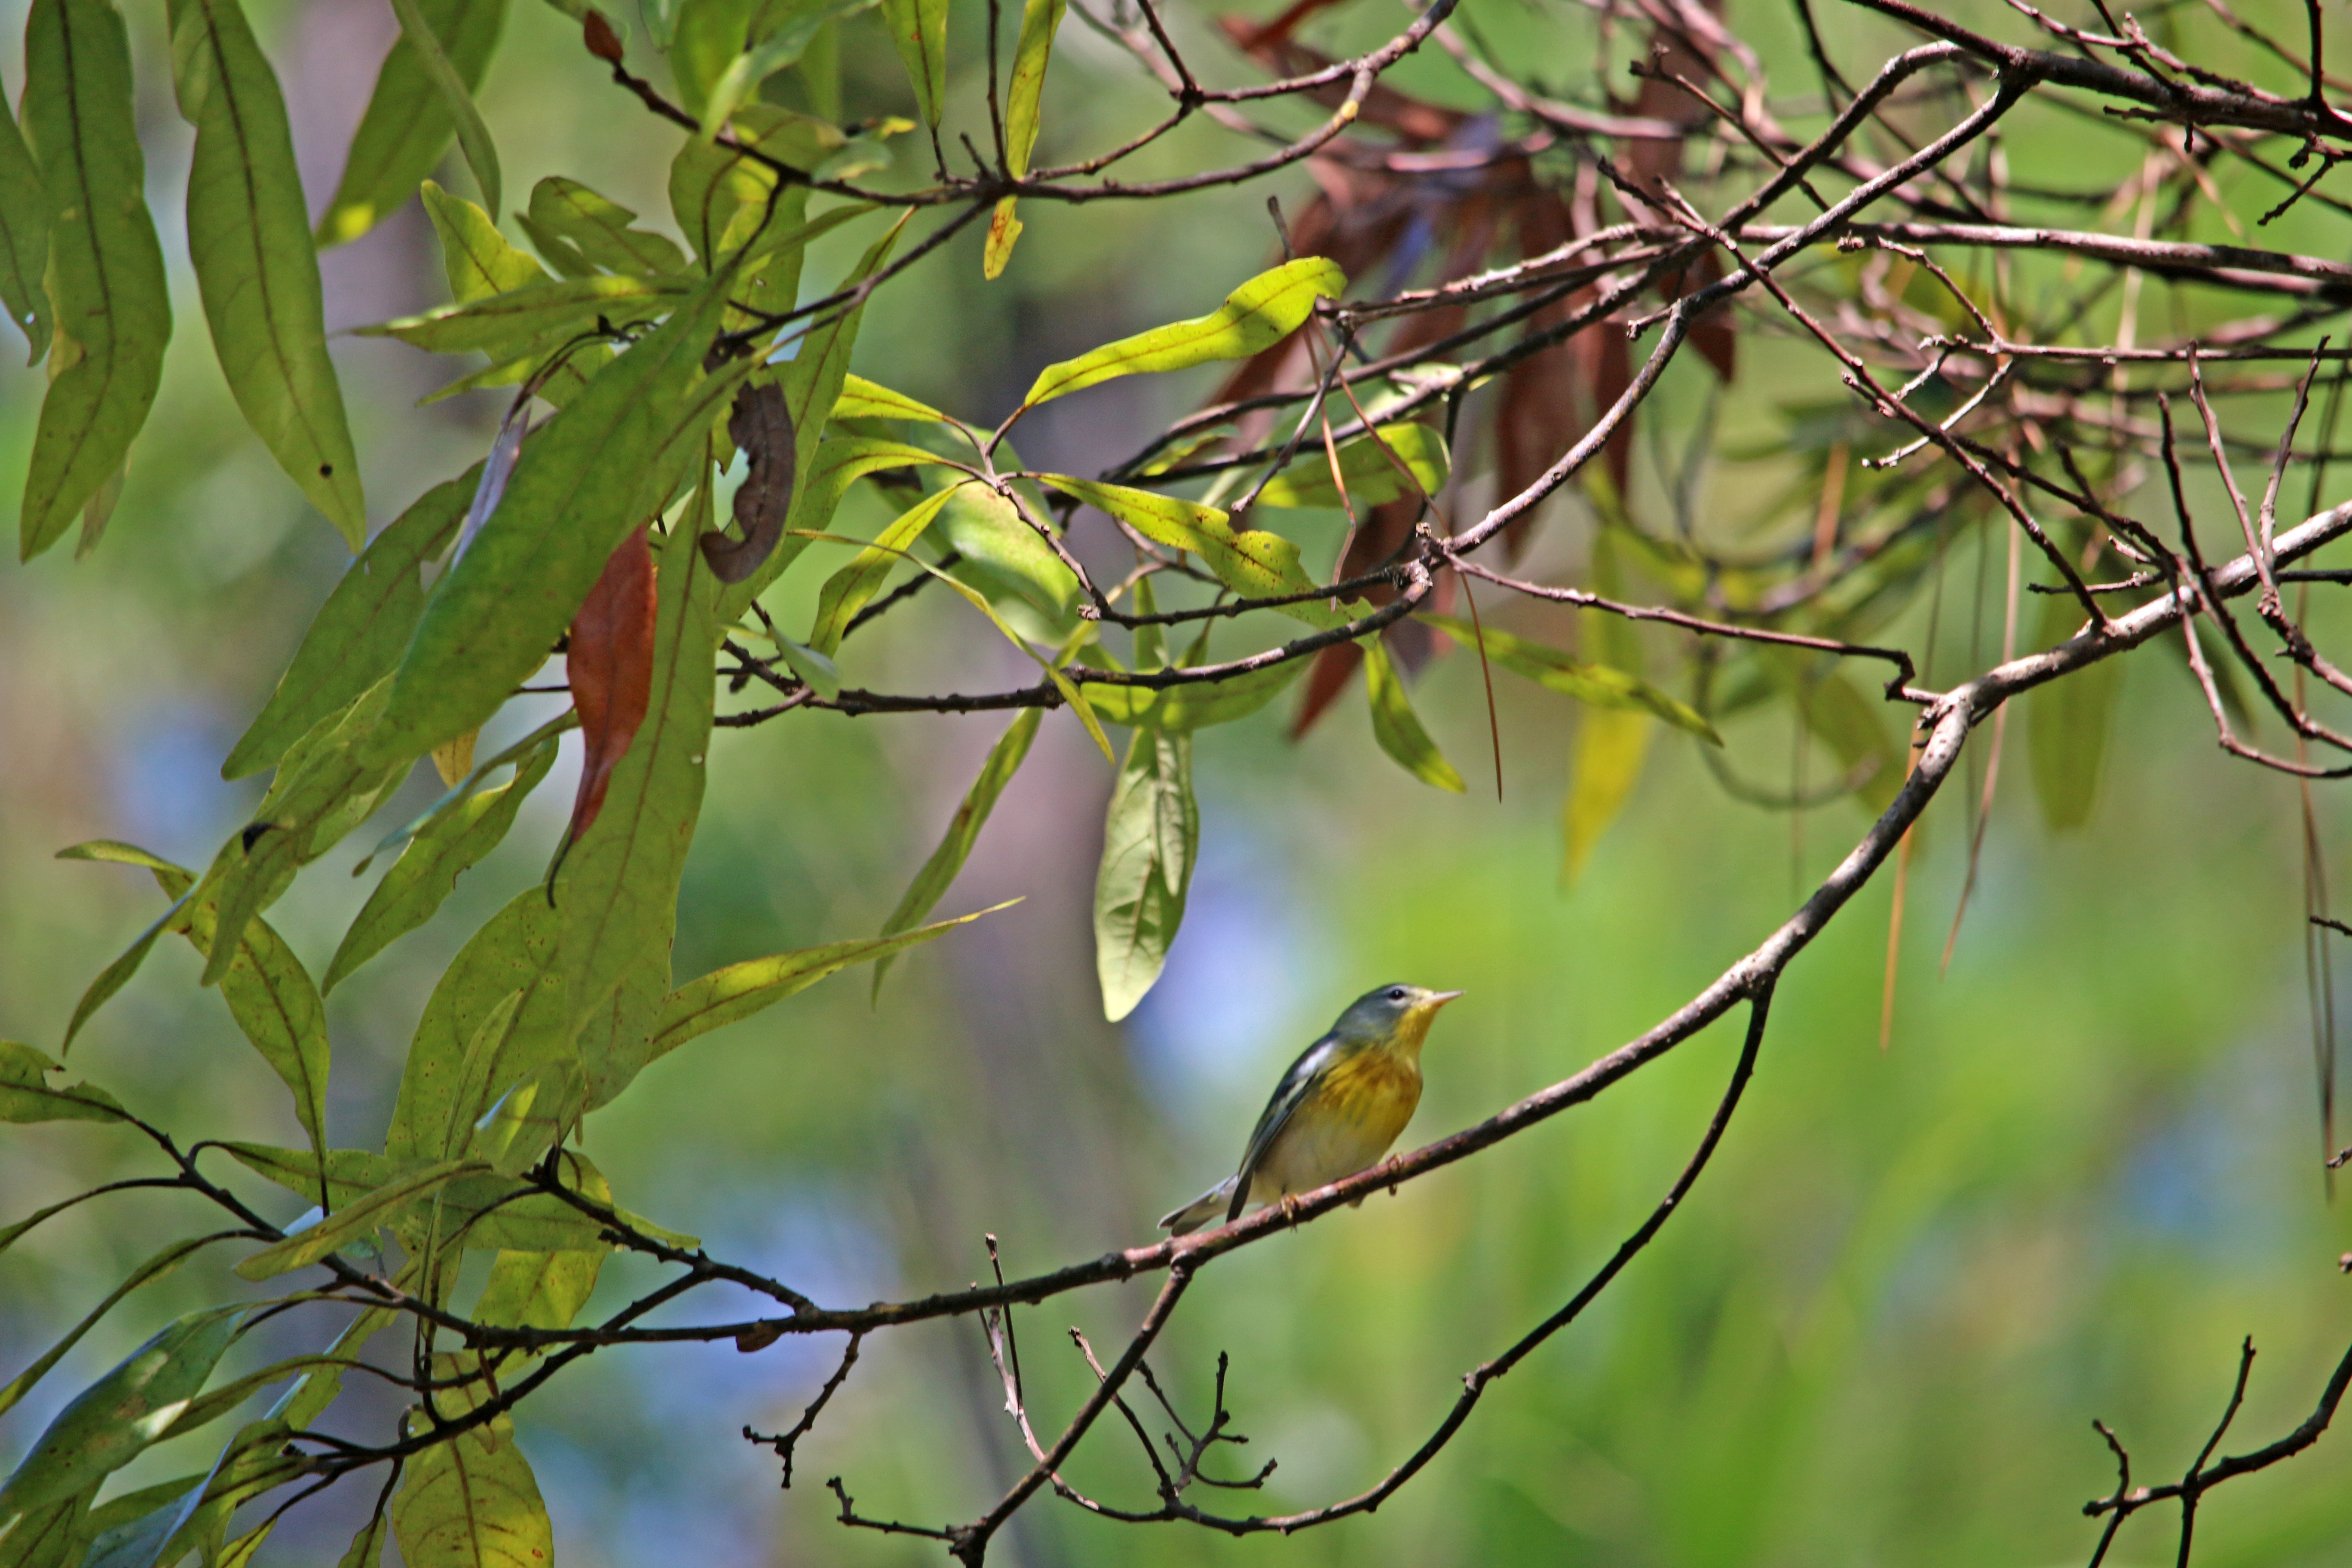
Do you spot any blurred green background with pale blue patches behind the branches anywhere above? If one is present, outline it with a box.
[0,0,2352,1568]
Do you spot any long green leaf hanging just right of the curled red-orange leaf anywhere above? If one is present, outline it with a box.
[553,512,720,1105]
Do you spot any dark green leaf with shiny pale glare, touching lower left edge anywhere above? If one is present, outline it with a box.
[0,1316,245,1519]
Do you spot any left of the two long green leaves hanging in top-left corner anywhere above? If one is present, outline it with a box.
[16,0,172,560]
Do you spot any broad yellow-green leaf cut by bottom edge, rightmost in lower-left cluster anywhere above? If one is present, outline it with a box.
[390,1357,555,1568]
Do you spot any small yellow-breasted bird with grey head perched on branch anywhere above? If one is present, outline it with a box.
[1160,985,1461,1237]
